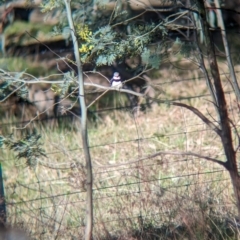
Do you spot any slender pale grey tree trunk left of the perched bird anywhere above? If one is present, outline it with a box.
[64,0,93,240]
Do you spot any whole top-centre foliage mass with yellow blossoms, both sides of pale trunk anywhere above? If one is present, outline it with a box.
[38,0,167,68]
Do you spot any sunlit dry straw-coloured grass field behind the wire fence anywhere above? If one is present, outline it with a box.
[1,54,239,240]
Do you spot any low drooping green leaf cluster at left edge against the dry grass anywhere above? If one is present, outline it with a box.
[0,131,46,167]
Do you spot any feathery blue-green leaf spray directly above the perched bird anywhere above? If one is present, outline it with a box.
[80,24,163,68]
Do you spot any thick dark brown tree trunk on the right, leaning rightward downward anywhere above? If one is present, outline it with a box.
[198,0,240,219]
